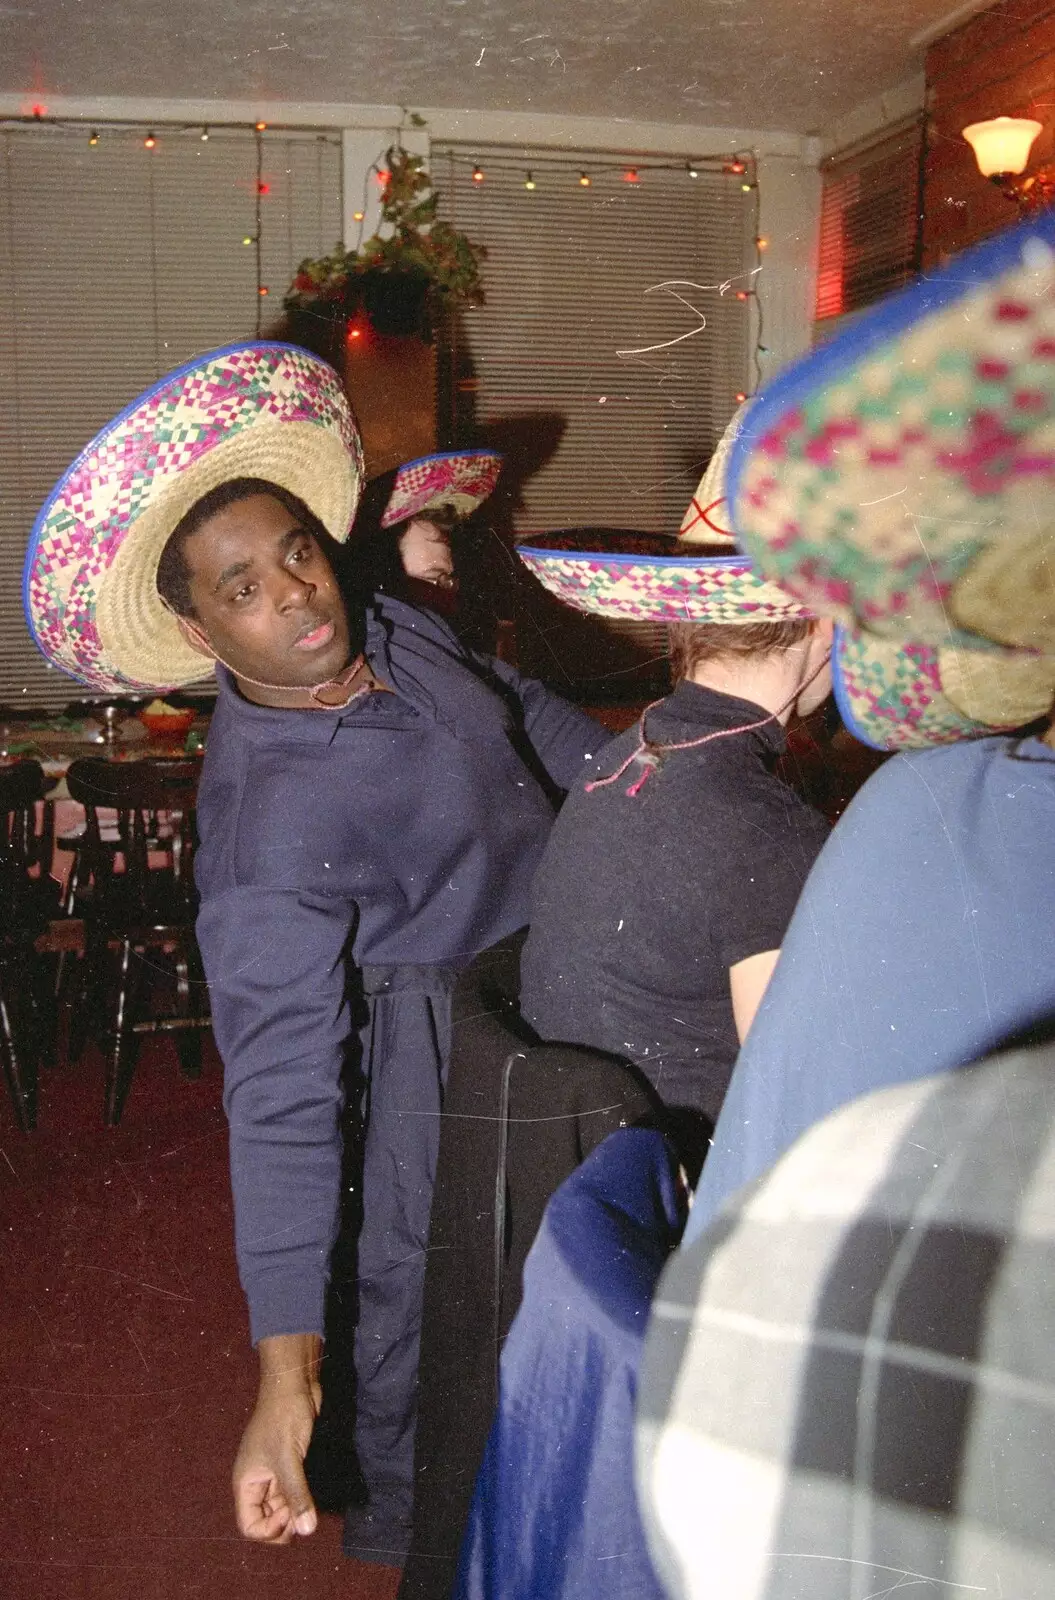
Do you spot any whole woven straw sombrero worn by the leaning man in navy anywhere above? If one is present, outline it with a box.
[24,344,362,690]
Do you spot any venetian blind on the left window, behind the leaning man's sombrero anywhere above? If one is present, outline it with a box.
[0,118,341,709]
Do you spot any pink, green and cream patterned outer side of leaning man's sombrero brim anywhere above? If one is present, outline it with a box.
[24,344,362,688]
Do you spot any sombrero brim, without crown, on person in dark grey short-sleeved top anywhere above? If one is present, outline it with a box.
[517,530,812,622]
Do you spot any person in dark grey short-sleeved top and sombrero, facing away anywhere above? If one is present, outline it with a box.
[520,406,832,1166]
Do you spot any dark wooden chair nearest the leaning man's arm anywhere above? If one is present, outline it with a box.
[66,757,210,1126]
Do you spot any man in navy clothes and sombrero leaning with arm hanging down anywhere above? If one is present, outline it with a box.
[26,344,607,1565]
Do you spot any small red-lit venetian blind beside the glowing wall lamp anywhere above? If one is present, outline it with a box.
[816,118,922,336]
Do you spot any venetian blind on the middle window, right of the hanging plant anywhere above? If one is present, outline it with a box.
[432,146,756,694]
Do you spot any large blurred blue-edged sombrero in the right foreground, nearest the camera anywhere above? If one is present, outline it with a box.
[728,213,1055,650]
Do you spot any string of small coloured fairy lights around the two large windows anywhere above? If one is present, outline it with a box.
[0,113,768,403]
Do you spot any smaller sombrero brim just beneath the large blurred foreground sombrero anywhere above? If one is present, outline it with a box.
[831,627,1055,750]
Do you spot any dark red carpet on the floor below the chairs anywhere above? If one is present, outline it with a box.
[0,1042,399,1600]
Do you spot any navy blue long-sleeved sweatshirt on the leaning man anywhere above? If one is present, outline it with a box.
[197,597,608,1339]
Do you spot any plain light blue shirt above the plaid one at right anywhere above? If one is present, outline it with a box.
[690,738,1055,1237]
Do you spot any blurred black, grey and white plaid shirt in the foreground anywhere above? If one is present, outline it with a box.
[636,1029,1055,1600]
